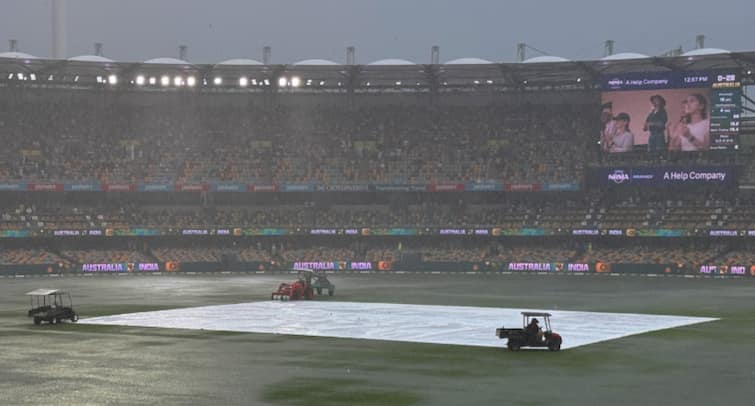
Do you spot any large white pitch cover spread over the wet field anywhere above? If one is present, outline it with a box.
[79,301,717,349]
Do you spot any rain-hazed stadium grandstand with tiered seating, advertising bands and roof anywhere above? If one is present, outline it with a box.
[0,53,755,276]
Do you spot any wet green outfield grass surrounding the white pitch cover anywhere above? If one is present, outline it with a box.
[0,275,755,405]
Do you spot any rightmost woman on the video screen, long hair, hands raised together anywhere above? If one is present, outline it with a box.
[668,93,710,151]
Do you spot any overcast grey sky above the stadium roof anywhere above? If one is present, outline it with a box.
[0,0,755,63]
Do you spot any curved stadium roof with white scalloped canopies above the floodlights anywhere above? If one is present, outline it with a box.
[0,50,755,91]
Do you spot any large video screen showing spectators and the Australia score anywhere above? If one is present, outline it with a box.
[600,71,742,153]
